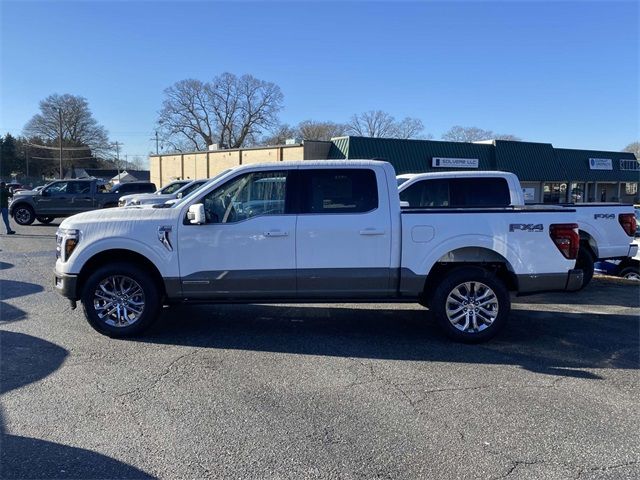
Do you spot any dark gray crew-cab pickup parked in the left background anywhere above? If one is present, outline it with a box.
[9,178,156,225]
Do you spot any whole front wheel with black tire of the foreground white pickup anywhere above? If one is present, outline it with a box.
[82,263,161,338]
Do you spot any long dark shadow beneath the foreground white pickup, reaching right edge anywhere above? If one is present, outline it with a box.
[141,305,640,379]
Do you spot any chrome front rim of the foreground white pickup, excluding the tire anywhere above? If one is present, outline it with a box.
[93,275,145,327]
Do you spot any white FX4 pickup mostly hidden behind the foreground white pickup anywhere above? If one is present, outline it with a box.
[397,171,638,287]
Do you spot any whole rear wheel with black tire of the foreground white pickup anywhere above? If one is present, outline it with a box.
[429,267,511,343]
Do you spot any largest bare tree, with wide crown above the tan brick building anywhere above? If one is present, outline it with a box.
[158,73,283,150]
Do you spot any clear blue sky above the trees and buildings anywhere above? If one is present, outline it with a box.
[0,0,640,163]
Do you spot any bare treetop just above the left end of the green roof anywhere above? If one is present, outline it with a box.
[346,110,424,139]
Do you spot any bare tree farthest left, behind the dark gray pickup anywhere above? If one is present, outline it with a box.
[24,94,111,156]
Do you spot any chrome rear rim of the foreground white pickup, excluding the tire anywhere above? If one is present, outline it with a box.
[445,281,499,333]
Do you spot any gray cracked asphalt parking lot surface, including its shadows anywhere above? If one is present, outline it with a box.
[0,223,640,479]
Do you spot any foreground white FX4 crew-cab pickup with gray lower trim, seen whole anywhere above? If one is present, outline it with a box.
[55,160,582,342]
